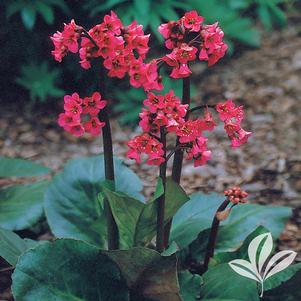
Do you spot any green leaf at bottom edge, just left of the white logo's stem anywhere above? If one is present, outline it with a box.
[201,263,259,301]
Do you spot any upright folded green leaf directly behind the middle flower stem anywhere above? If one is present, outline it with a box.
[135,179,189,245]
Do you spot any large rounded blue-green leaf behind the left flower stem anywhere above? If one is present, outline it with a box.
[45,156,142,247]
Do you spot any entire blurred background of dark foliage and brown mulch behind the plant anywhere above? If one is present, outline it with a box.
[0,0,301,300]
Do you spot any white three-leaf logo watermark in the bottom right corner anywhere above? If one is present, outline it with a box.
[229,233,297,297]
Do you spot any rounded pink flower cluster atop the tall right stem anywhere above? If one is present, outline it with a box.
[158,11,228,78]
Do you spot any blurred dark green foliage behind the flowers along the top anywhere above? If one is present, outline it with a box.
[0,0,294,123]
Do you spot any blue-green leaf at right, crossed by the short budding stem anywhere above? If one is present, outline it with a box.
[170,193,292,252]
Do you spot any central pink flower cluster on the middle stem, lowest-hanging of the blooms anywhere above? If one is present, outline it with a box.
[127,90,216,166]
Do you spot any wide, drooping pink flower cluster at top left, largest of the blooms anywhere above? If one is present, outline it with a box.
[51,12,163,91]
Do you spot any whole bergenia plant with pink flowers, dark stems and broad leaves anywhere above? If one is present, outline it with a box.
[1,11,297,301]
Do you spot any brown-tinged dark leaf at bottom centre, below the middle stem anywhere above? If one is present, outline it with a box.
[105,248,182,301]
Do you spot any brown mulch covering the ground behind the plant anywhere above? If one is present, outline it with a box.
[0,19,301,301]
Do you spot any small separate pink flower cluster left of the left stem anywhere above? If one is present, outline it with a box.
[58,92,107,137]
